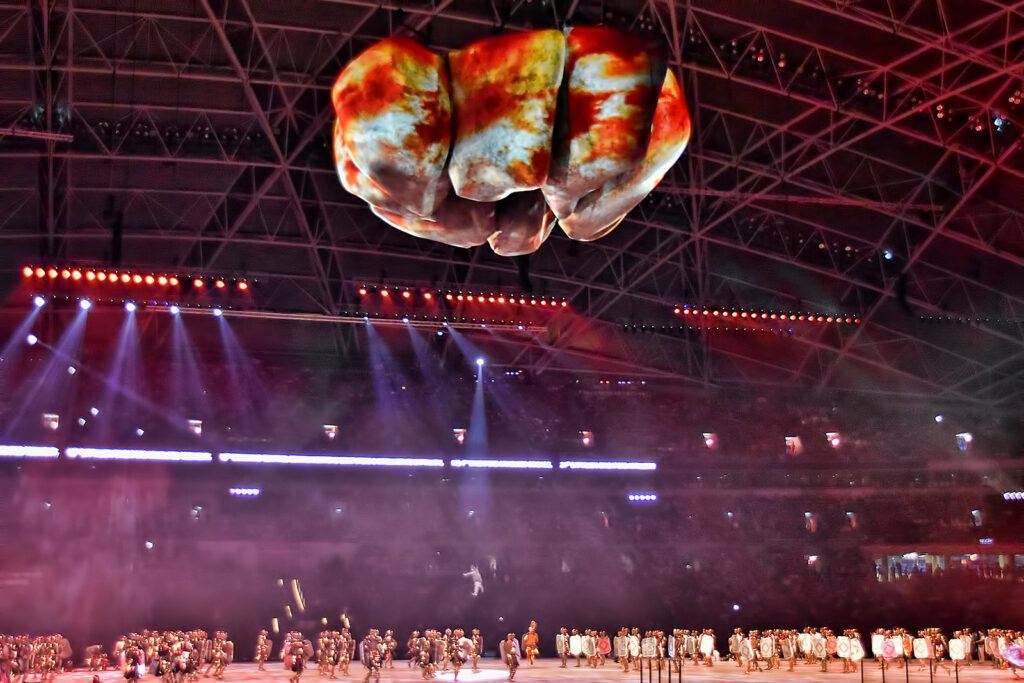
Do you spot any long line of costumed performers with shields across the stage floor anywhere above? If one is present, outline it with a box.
[0,622,1024,683]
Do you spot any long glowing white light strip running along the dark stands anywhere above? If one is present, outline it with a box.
[0,445,657,471]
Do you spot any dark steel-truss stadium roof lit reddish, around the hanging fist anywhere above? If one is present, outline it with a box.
[0,0,1024,403]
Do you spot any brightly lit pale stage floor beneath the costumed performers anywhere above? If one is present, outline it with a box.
[74,659,1013,683]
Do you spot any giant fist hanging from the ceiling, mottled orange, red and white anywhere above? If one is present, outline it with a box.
[332,27,690,256]
